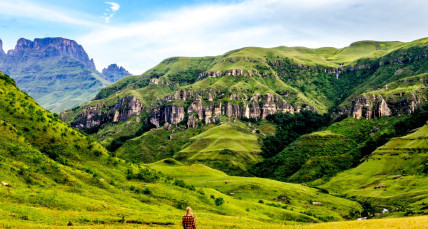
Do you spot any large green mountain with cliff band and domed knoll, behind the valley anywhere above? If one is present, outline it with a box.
[61,39,428,175]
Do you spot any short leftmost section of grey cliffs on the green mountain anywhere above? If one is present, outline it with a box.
[72,96,143,129]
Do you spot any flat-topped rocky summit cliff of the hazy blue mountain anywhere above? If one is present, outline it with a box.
[7,37,95,69]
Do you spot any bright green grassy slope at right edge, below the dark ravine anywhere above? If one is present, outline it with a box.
[321,125,428,212]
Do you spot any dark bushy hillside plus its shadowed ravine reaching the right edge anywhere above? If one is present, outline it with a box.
[253,107,428,184]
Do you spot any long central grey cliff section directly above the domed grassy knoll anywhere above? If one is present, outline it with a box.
[150,90,308,128]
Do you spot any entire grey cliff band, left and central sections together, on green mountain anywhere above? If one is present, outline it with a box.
[72,90,315,129]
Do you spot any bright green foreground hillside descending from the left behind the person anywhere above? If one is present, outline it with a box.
[0,73,368,228]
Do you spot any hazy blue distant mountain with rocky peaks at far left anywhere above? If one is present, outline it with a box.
[0,38,131,113]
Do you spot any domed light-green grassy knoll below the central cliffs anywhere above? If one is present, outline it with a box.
[175,124,262,174]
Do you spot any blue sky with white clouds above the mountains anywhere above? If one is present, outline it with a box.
[0,0,428,74]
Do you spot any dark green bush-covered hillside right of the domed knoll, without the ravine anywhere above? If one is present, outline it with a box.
[270,117,399,184]
